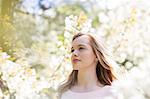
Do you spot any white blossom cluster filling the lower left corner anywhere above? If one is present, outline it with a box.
[0,52,50,99]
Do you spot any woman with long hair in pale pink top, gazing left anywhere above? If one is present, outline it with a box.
[59,33,117,99]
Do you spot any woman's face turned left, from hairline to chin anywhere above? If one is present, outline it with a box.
[71,35,96,70]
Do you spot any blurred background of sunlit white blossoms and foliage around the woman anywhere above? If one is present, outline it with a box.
[0,0,150,99]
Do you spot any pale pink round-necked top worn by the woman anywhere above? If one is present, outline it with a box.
[61,86,120,99]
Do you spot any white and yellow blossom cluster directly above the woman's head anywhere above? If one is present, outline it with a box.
[65,13,94,34]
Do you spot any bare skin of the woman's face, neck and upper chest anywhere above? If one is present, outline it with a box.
[71,35,103,92]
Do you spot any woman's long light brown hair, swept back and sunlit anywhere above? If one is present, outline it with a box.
[59,33,116,96]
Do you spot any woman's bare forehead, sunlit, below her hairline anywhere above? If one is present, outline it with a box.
[72,35,90,46]
